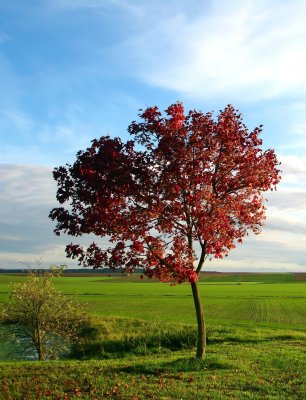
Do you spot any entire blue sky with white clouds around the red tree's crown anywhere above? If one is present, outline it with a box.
[0,0,306,272]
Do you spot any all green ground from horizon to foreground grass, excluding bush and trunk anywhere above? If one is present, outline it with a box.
[0,274,306,400]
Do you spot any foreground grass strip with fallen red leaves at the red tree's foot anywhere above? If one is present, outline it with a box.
[0,341,306,400]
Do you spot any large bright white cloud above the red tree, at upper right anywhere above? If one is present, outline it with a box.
[121,0,306,101]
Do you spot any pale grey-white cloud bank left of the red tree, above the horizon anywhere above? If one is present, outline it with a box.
[0,164,109,268]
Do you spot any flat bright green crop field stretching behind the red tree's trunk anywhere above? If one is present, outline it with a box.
[0,274,306,330]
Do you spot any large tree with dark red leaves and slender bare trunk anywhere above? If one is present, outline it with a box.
[50,103,280,358]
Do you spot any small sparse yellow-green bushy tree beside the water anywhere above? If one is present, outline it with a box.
[0,269,87,360]
